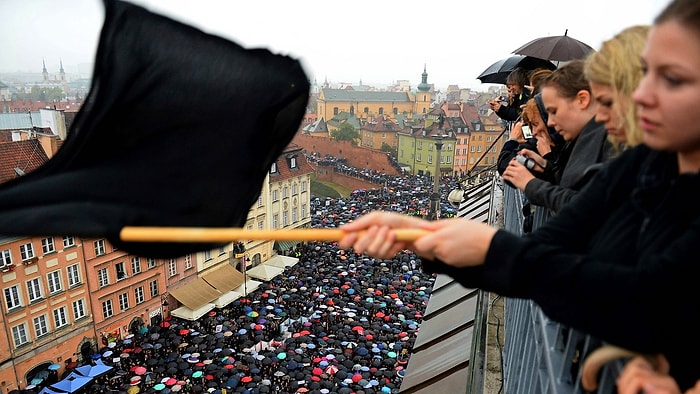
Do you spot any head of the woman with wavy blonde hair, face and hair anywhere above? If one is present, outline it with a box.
[584,25,649,148]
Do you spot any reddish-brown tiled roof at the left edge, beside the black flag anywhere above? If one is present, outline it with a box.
[0,139,49,183]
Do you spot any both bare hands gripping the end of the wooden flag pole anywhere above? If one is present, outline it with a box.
[338,211,496,267]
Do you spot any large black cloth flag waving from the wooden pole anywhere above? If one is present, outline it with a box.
[0,0,309,258]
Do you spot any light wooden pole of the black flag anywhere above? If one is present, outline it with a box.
[119,226,428,242]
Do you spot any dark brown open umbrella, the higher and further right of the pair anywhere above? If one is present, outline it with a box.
[513,29,594,62]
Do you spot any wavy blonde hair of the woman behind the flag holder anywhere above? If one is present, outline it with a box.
[584,25,649,146]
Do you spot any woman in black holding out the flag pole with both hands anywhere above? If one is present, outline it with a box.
[339,0,700,390]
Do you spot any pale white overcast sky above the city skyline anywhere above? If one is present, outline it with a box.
[0,0,669,90]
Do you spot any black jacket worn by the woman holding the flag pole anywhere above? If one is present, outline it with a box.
[426,146,700,390]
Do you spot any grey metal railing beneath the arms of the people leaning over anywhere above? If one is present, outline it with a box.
[494,186,623,394]
